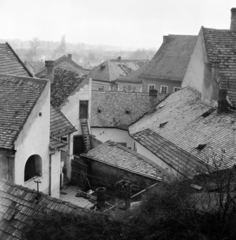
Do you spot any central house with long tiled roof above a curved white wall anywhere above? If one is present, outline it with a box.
[91,91,166,150]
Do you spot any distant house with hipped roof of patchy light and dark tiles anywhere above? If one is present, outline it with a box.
[88,57,148,92]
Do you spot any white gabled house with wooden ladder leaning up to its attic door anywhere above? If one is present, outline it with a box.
[44,61,91,180]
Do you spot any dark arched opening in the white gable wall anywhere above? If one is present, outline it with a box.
[24,154,42,182]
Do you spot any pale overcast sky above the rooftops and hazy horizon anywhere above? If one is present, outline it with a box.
[0,0,236,48]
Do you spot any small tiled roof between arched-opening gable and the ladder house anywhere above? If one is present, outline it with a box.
[50,105,76,149]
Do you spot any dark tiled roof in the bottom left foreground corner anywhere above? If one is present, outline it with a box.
[0,179,84,240]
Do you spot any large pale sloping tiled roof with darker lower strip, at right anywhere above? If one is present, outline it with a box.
[129,88,236,173]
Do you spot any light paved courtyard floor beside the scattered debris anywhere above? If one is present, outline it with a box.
[60,185,93,208]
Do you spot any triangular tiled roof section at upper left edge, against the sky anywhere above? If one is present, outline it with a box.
[0,43,32,77]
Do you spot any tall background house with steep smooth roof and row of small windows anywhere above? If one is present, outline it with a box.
[139,35,197,94]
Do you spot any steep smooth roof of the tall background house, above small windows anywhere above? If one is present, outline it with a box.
[141,35,197,81]
